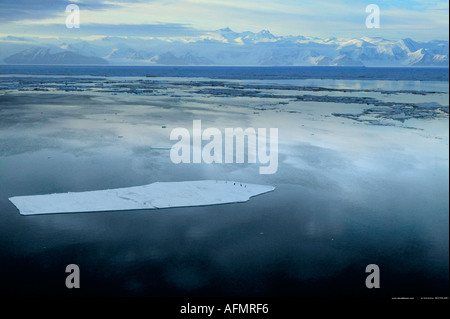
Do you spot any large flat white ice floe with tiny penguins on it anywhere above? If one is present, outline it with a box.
[9,181,275,215]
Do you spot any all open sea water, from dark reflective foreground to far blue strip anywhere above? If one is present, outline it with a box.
[0,66,449,298]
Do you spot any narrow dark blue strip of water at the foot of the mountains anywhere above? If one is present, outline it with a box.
[0,65,449,81]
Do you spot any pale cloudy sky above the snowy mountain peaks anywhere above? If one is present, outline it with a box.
[0,0,449,41]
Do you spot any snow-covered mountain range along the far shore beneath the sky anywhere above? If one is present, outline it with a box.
[0,28,449,67]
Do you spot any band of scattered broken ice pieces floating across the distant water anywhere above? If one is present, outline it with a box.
[0,76,449,128]
